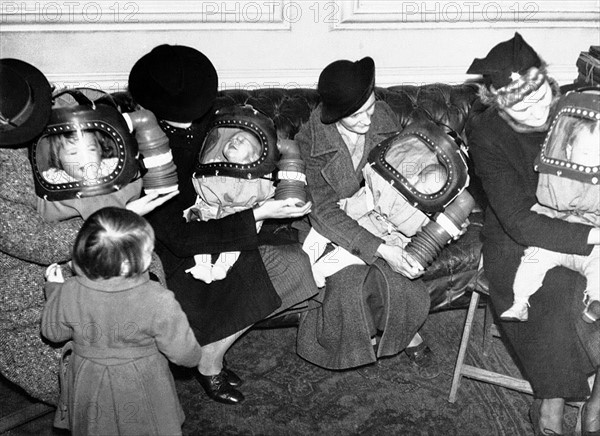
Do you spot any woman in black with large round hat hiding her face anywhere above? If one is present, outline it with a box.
[129,44,317,404]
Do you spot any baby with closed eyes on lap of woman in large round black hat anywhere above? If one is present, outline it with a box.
[184,129,275,283]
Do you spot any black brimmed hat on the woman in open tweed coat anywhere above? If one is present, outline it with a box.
[317,56,375,124]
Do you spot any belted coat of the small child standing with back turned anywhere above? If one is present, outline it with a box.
[42,273,202,435]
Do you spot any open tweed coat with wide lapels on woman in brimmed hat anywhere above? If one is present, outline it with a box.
[295,101,430,369]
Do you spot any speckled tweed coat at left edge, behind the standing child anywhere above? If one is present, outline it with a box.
[0,148,164,404]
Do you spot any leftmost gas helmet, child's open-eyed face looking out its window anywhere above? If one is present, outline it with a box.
[31,89,140,201]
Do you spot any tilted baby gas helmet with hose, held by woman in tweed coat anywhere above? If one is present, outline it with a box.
[368,122,475,268]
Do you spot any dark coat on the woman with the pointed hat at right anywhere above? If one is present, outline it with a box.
[466,99,600,399]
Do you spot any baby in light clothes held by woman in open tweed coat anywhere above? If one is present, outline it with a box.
[303,163,447,287]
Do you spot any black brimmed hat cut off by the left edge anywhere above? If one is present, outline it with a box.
[0,59,52,147]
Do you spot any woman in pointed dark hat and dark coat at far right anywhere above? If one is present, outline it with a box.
[467,33,600,435]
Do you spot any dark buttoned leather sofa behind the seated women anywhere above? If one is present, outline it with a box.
[216,83,485,311]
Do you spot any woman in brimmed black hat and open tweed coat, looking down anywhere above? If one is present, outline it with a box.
[295,57,439,378]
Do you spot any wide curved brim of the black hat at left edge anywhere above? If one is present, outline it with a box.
[0,59,52,147]
